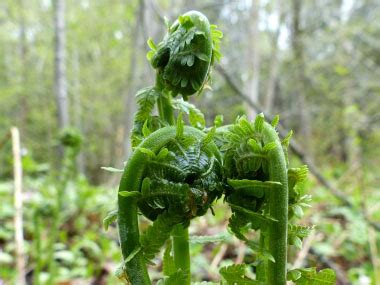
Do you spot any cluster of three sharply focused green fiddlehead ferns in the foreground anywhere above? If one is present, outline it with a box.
[105,11,335,285]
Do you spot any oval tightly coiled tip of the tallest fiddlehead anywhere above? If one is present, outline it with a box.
[147,11,222,98]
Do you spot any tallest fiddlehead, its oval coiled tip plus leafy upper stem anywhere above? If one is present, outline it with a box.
[132,11,223,146]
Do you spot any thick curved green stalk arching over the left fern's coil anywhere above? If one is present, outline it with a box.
[118,126,220,285]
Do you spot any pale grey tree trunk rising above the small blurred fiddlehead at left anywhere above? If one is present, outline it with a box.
[54,0,69,129]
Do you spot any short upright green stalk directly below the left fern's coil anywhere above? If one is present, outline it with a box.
[172,225,191,284]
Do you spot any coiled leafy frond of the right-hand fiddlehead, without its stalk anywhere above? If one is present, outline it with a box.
[222,115,281,243]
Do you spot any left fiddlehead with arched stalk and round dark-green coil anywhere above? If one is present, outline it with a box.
[118,123,223,284]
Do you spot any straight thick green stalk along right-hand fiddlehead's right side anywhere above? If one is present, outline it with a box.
[263,123,288,285]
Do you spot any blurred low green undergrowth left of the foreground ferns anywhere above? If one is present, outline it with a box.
[0,176,119,284]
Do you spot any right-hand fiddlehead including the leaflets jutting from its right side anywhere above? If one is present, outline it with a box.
[218,114,335,284]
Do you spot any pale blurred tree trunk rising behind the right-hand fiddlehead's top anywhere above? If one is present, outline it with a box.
[247,0,260,120]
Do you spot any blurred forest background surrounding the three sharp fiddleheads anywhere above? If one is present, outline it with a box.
[0,0,380,285]
